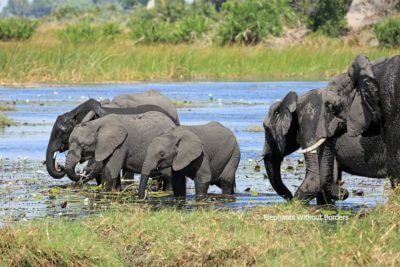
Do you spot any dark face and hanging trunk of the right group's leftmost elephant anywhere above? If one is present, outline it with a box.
[263,92,299,199]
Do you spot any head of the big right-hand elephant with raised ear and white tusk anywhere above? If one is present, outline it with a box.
[306,55,380,151]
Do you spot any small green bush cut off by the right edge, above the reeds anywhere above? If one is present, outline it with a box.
[374,18,400,47]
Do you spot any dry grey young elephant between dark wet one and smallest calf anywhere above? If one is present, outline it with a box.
[65,111,176,190]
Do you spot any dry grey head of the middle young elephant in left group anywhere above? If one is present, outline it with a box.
[65,120,128,181]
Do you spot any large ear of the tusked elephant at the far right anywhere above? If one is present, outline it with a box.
[347,56,380,136]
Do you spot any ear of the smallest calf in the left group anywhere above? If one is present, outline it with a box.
[172,131,203,171]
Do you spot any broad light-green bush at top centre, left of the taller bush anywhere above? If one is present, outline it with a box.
[129,0,216,44]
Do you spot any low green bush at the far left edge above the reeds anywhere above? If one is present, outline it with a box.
[0,17,38,41]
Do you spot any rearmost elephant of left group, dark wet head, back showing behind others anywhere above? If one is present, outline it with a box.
[46,90,179,179]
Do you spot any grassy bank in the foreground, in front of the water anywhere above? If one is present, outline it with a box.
[0,196,400,266]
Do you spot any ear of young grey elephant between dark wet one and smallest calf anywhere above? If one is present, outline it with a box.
[95,125,128,161]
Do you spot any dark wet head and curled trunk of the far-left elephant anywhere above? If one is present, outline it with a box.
[46,99,100,179]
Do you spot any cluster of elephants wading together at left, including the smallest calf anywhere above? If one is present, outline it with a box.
[46,91,240,198]
